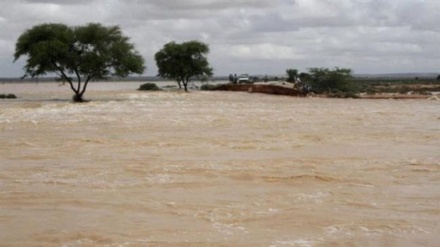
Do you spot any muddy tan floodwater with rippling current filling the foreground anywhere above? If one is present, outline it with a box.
[0,83,440,247]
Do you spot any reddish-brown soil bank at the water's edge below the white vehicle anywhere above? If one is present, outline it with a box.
[213,84,306,96]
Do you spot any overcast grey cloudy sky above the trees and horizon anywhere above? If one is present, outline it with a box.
[0,0,440,77]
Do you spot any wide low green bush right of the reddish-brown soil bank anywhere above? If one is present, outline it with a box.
[309,68,356,93]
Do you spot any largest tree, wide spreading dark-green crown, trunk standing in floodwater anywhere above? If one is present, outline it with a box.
[14,23,145,102]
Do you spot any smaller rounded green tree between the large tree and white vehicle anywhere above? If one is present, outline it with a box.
[154,41,212,91]
